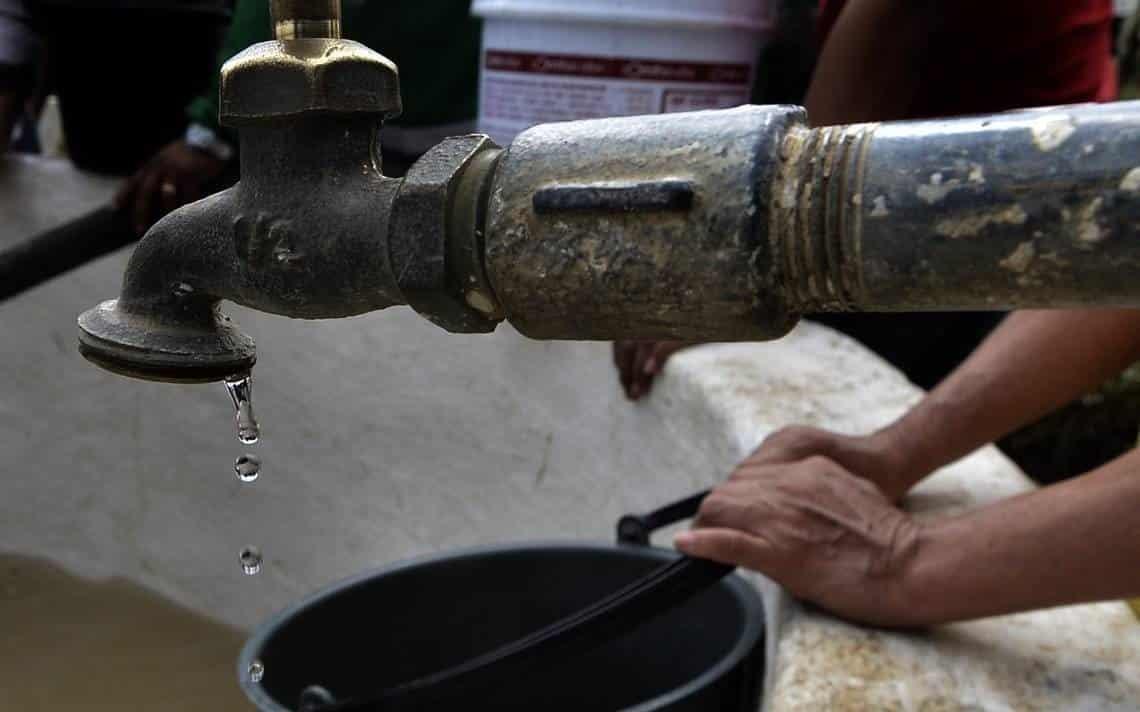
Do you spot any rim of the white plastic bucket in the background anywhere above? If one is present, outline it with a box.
[471,0,776,33]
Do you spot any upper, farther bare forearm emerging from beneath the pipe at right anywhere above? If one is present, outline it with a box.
[873,310,1140,492]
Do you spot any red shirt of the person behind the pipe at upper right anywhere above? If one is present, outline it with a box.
[820,0,1118,117]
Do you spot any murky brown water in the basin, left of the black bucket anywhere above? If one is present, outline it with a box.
[0,555,251,712]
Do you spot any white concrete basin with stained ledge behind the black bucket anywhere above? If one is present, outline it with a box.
[0,153,1140,710]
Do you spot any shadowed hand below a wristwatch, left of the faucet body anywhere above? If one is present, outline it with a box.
[115,139,226,235]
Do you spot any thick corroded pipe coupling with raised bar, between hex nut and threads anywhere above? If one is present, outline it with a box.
[486,107,805,341]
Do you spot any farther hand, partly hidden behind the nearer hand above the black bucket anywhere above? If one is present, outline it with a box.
[733,425,926,501]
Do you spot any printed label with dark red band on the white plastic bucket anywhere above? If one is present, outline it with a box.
[479,49,752,142]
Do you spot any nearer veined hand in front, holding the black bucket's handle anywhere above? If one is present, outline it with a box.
[675,456,920,625]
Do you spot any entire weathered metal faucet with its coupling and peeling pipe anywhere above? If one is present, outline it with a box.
[80,0,1140,382]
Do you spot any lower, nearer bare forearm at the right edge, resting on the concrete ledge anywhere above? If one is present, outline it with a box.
[902,451,1140,624]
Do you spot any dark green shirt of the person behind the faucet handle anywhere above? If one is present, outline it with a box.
[187,0,481,136]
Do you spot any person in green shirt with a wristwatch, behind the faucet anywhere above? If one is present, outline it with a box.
[111,0,481,235]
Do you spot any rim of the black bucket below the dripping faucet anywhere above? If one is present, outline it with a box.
[237,539,766,712]
